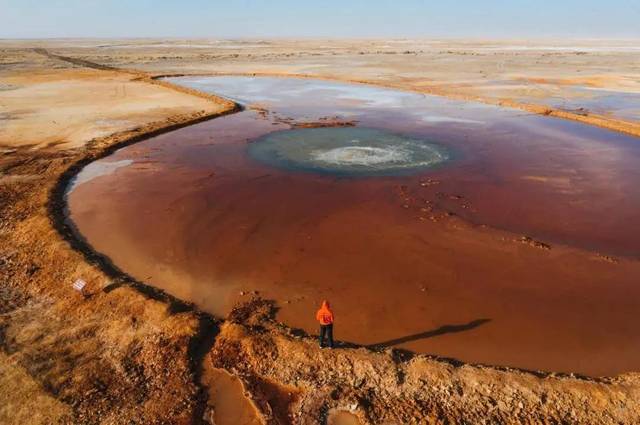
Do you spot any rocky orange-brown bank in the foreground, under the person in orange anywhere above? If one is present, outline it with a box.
[211,299,640,424]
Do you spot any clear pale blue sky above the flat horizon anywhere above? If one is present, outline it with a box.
[0,0,640,38]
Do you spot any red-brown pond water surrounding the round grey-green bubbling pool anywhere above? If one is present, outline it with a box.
[68,77,640,375]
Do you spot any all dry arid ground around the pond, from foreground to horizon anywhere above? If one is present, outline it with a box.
[0,39,640,424]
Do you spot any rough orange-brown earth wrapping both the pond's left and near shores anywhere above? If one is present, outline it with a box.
[0,41,640,424]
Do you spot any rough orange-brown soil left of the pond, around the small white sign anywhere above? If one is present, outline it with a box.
[0,58,235,424]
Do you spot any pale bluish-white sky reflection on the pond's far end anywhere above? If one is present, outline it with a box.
[171,77,508,126]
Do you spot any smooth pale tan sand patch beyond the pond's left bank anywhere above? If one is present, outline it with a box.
[0,69,223,148]
